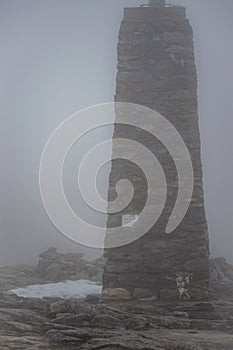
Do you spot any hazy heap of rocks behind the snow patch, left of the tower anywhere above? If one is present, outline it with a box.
[0,248,104,290]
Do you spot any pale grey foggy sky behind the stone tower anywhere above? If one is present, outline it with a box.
[0,0,233,265]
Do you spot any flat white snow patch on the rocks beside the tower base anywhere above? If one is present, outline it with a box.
[11,280,102,298]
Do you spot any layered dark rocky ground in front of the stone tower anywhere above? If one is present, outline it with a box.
[0,250,233,350]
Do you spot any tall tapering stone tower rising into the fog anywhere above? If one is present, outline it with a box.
[103,6,209,300]
